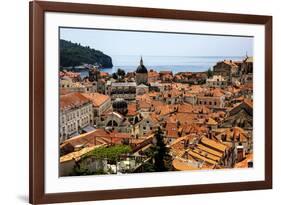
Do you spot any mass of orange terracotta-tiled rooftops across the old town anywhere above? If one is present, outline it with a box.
[60,58,253,173]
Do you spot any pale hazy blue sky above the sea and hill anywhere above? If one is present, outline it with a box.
[60,28,253,56]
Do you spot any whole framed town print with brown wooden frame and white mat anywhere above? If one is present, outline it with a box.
[30,1,272,204]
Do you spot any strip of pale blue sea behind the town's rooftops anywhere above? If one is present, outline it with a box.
[77,55,245,78]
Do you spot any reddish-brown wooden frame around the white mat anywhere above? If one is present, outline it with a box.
[29,1,272,204]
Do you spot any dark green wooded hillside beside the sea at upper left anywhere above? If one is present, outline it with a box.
[60,39,113,68]
